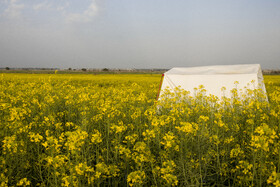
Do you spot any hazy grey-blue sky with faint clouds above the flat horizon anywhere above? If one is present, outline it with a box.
[0,0,280,69]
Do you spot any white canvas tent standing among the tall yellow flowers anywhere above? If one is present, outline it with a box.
[158,64,266,98]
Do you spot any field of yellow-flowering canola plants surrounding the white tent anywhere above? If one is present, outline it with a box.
[0,73,280,186]
